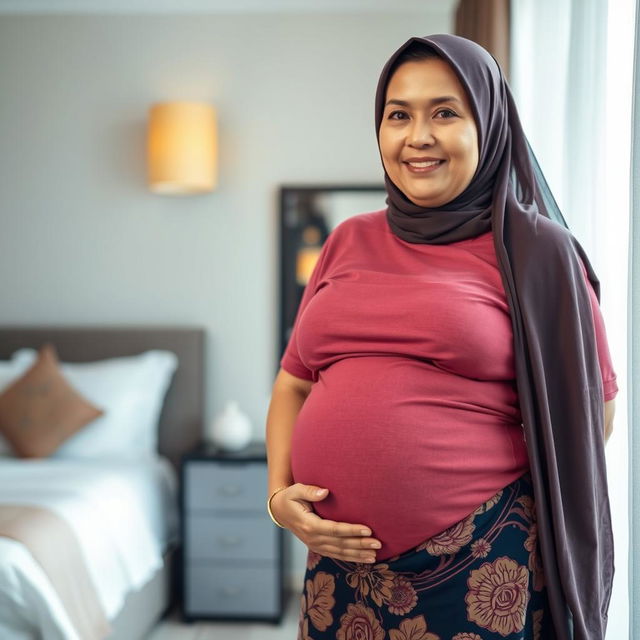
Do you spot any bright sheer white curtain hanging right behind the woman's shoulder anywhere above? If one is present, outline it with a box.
[511,0,640,640]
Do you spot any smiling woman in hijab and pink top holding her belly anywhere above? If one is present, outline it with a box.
[267,35,617,640]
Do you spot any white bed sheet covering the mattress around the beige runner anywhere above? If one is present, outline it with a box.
[0,457,179,640]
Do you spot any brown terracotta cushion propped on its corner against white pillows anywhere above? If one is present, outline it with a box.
[0,344,104,458]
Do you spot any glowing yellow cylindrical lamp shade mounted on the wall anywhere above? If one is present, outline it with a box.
[147,102,218,195]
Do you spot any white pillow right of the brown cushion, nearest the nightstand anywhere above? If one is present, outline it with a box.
[13,349,178,459]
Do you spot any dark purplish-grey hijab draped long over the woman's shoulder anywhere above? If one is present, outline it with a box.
[375,34,613,640]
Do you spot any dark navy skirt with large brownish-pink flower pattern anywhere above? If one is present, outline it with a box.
[298,473,555,640]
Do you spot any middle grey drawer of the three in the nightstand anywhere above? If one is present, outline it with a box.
[185,514,278,561]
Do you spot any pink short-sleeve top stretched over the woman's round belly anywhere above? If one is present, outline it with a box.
[280,210,618,560]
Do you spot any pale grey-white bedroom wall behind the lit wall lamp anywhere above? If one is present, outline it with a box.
[0,10,450,592]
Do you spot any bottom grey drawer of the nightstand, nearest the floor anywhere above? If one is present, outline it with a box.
[184,564,280,617]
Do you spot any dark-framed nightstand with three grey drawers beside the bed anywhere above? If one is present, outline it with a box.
[181,442,284,622]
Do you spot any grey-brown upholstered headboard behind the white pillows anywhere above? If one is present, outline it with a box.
[0,326,205,468]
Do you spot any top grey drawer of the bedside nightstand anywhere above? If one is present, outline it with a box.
[185,461,267,511]
